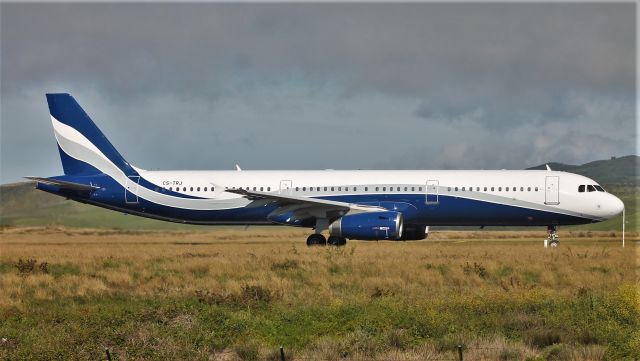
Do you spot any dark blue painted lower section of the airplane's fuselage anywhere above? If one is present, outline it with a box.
[43,176,593,226]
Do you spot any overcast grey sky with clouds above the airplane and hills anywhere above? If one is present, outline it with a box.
[0,3,638,183]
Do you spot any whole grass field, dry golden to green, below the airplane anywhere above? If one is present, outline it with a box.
[0,227,640,360]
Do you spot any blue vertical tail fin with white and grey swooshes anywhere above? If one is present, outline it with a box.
[47,94,137,175]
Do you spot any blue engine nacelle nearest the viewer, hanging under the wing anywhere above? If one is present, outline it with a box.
[329,211,403,240]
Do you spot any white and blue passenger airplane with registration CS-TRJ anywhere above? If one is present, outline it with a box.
[25,93,624,247]
